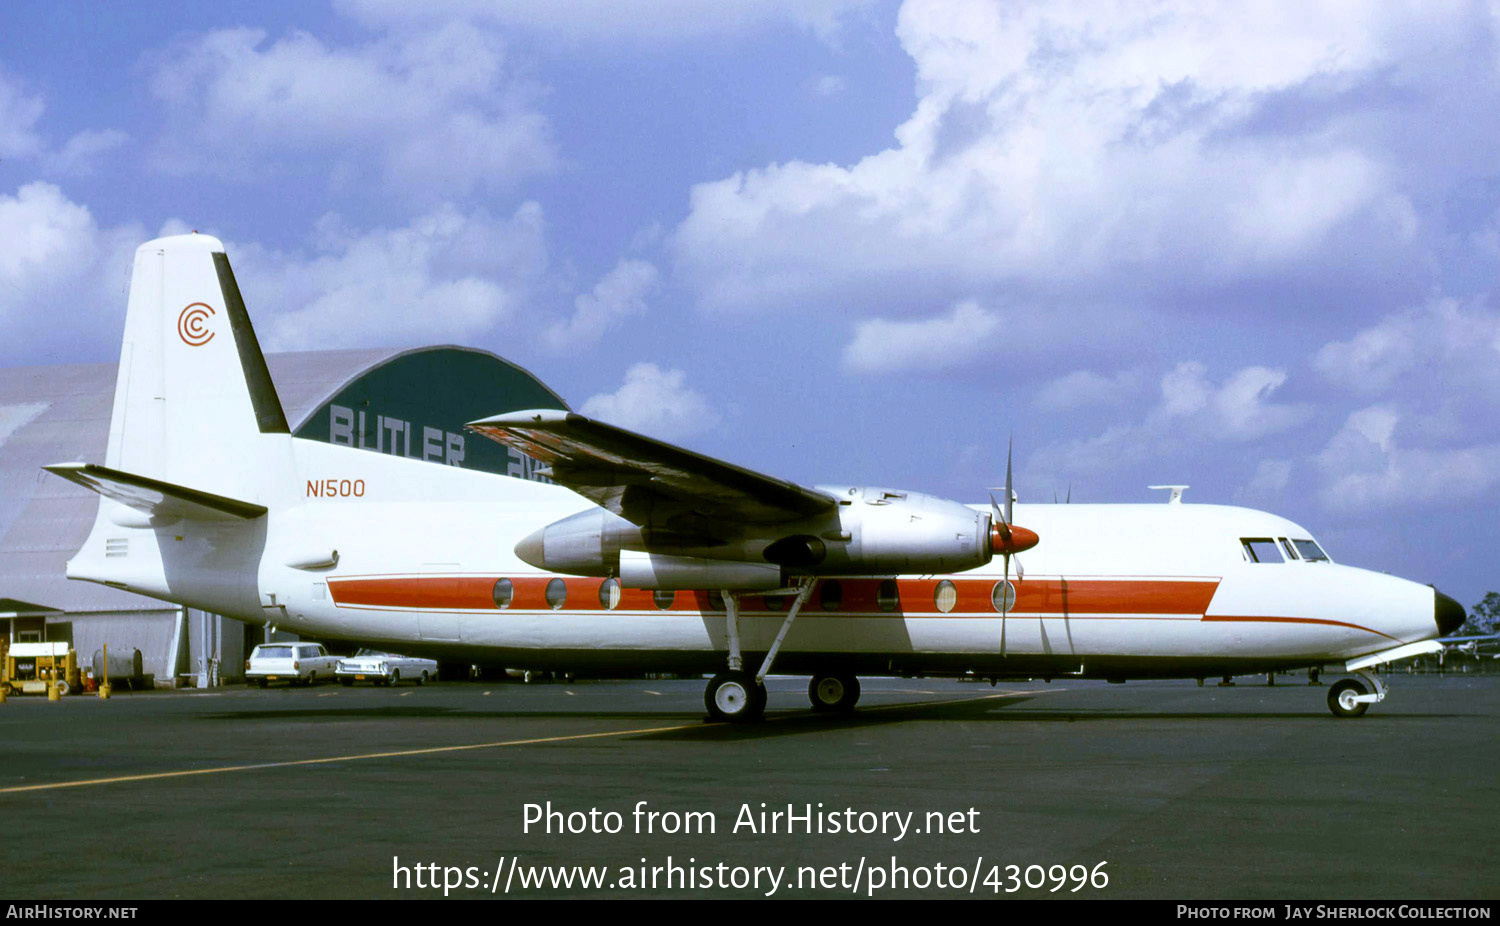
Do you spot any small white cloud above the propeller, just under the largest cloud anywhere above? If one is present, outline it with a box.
[843,302,1001,372]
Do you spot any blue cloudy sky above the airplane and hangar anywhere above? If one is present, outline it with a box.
[0,0,1500,603]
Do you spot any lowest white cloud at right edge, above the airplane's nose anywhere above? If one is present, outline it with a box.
[1313,405,1500,512]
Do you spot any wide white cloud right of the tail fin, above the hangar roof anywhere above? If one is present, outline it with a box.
[240,203,548,350]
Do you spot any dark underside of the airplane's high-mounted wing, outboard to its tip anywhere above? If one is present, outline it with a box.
[467,408,839,525]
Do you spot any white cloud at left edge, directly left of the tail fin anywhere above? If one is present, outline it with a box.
[0,182,146,363]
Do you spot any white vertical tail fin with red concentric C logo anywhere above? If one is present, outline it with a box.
[105,234,288,497]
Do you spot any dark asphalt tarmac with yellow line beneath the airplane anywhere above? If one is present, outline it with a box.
[0,675,1500,900]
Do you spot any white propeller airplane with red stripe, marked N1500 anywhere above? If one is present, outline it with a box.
[47,234,1464,720]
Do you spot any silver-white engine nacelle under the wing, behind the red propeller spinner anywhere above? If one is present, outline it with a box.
[516,486,992,576]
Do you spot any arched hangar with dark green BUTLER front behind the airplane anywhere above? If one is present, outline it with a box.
[0,345,567,687]
